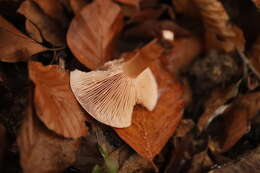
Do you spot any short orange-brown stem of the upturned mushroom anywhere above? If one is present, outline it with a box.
[123,40,164,78]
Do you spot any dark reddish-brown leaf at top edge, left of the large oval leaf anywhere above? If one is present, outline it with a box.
[33,0,68,27]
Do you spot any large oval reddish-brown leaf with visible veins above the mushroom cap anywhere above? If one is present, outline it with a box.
[67,0,123,69]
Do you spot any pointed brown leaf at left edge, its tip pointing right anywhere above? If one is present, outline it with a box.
[0,16,47,62]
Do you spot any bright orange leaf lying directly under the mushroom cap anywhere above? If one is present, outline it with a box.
[115,61,184,160]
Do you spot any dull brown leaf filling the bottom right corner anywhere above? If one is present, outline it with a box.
[209,146,260,173]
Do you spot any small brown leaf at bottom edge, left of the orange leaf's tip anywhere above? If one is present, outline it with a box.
[118,154,154,173]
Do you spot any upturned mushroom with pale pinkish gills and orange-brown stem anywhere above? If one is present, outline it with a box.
[70,31,173,128]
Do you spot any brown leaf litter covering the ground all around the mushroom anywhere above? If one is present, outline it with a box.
[0,0,260,173]
